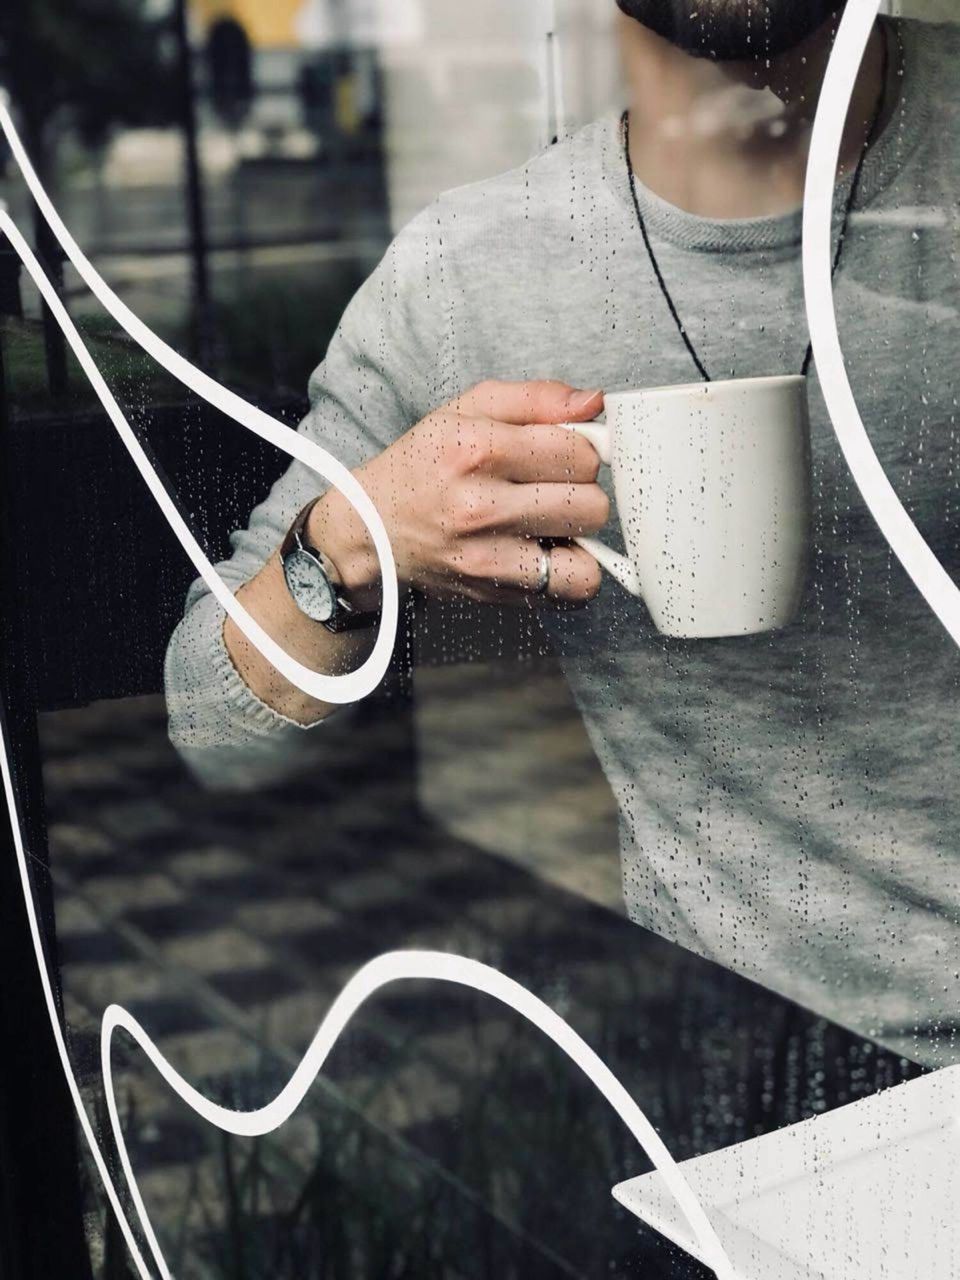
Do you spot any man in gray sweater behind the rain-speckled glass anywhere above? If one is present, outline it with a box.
[166,0,960,1064]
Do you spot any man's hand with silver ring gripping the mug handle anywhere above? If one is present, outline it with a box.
[308,381,609,608]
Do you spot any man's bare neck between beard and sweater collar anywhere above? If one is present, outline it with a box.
[622,18,893,218]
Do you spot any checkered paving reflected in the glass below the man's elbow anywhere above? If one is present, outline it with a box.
[41,668,824,1280]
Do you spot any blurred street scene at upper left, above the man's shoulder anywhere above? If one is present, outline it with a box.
[0,0,617,399]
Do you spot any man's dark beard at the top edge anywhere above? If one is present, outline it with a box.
[617,0,846,61]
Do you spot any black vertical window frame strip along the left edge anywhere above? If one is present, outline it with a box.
[0,314,91,1280]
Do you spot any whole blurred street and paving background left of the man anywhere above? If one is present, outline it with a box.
[0,0,632,1280]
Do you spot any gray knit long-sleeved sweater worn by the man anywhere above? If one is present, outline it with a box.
[166,24,960,1062]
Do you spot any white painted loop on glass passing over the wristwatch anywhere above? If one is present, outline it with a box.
[0,90,399,704]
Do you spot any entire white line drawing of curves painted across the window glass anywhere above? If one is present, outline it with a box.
[0,0,960,1280]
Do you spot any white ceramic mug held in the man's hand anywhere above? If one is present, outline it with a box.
[570,376,810,637]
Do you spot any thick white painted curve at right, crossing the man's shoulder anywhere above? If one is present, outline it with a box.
[803,0,960,645]
